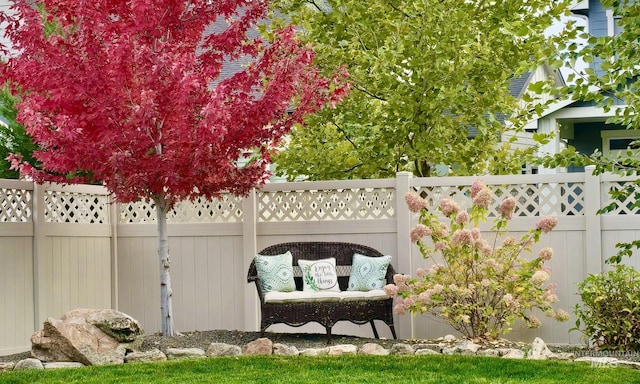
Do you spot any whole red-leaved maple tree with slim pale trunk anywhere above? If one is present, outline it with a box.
[0,0,347,335]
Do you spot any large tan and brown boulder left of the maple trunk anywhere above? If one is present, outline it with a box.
[31,309,143,365]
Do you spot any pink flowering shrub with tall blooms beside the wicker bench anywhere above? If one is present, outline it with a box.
[385,180,569,338]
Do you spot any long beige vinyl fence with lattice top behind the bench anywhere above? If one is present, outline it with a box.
[0,166,640,355]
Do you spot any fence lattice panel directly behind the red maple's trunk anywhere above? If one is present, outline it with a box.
[120,194,242,223]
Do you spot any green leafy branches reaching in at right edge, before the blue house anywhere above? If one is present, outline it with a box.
[542,0,640,263]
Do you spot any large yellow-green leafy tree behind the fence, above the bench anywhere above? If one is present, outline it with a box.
[272,0,571,180]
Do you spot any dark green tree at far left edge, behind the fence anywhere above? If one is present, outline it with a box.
[0,86,37,179]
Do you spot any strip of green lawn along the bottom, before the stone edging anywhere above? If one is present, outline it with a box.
[0,355,640,384]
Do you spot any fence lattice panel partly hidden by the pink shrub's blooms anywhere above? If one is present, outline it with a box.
[414,182,584,217]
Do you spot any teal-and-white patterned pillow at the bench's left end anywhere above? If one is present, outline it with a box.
[255,251,296,292]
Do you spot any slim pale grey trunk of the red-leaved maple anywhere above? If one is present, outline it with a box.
[154,198,176,336]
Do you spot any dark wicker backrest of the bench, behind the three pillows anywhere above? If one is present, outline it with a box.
[247,241,395,291]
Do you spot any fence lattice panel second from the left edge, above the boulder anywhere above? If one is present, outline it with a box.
[44,191,109,224]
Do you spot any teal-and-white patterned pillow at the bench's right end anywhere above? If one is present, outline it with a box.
[347,253,391,291]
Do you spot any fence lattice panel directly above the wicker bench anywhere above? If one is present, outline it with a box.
[258,188,396,222]
